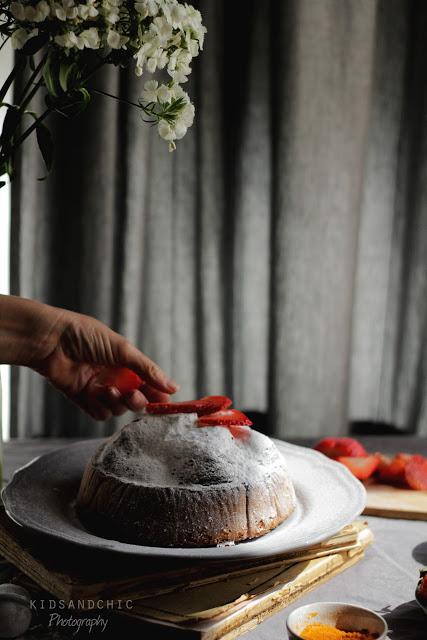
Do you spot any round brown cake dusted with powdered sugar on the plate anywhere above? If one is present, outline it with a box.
[76,413,296,547]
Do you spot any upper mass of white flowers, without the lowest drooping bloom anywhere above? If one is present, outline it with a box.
[10,0,206,56]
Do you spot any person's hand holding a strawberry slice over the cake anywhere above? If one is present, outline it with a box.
[28,305,178,420]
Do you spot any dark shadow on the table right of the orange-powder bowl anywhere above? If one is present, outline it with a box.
[378,600,426,640]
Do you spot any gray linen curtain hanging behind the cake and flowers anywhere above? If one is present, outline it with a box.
[8,0,427,437]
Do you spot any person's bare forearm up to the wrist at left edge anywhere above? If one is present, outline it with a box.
[0,295,64,366]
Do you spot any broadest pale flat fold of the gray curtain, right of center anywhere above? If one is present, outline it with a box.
[270,0,375,435]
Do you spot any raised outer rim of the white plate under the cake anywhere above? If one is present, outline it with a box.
[1,438,366,561]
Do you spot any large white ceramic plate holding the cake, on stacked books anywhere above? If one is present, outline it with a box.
[2,439,366,561]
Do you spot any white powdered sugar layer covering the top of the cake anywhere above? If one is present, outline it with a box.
[96,413,286,489]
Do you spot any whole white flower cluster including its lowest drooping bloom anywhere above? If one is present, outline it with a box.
[6,0,206,148]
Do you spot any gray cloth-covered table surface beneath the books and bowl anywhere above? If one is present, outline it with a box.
[4,437,427,640]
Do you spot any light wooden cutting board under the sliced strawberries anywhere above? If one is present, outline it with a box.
[363,484,427,520]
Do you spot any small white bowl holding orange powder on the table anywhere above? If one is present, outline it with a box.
[286,602,388,640]
